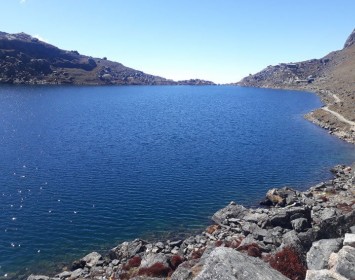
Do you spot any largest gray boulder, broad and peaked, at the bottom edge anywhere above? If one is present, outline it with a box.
[172,247,288,280]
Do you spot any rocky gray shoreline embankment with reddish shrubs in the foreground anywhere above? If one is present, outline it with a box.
[28,166,355,280]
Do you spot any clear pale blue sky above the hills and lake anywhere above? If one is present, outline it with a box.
[0,0,355,83]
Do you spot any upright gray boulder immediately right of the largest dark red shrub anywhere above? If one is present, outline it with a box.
[307,238,342,270]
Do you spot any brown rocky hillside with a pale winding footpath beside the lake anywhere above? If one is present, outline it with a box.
[237,29,355,143]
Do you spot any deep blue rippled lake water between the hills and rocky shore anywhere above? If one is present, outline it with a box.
[0,86,355,275]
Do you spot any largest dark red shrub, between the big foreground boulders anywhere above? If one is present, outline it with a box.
[268,247,307,280]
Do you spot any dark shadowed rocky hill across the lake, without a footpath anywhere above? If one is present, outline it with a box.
[0,32,214,85]
